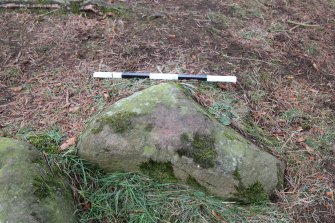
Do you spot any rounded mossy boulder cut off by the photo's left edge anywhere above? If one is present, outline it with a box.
[0,137,74,223]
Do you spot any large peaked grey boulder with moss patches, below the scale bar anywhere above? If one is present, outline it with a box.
[78,83,284,197]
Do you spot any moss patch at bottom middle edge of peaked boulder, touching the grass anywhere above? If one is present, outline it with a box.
[140,159,178,183]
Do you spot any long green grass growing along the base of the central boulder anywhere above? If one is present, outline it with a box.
[49,151,288,223]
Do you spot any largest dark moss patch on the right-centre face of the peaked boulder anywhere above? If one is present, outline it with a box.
[177,134,217,168]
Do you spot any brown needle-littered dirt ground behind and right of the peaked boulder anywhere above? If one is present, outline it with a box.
[0,0,335,222]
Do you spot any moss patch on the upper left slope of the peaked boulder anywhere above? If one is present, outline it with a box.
[91,112,136,134]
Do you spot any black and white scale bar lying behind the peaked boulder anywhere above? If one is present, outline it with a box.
[93,72,236,83]
